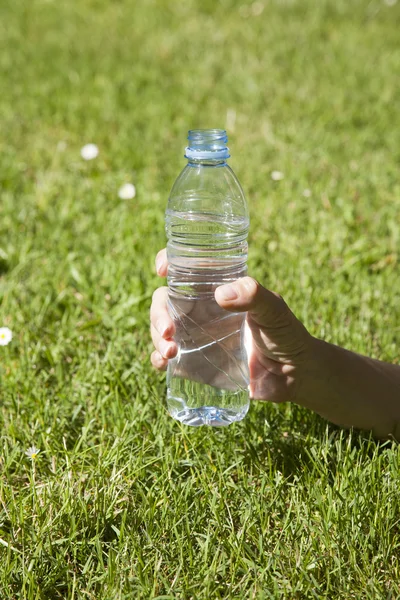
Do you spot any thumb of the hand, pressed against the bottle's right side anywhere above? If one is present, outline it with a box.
[215,277,289,325]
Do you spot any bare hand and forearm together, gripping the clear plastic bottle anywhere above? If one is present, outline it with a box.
[150,249,400,439]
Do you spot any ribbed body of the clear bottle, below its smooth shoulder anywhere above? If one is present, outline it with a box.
[166,209,249,426]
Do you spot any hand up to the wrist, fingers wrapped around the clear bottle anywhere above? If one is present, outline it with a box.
[150,249,313,402]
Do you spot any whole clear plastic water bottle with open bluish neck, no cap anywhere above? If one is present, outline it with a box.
[165,129,249,426]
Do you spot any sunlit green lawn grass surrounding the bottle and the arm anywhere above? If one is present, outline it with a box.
[0,0,400,600]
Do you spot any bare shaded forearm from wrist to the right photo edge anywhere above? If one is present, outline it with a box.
[299,338,400,439]
